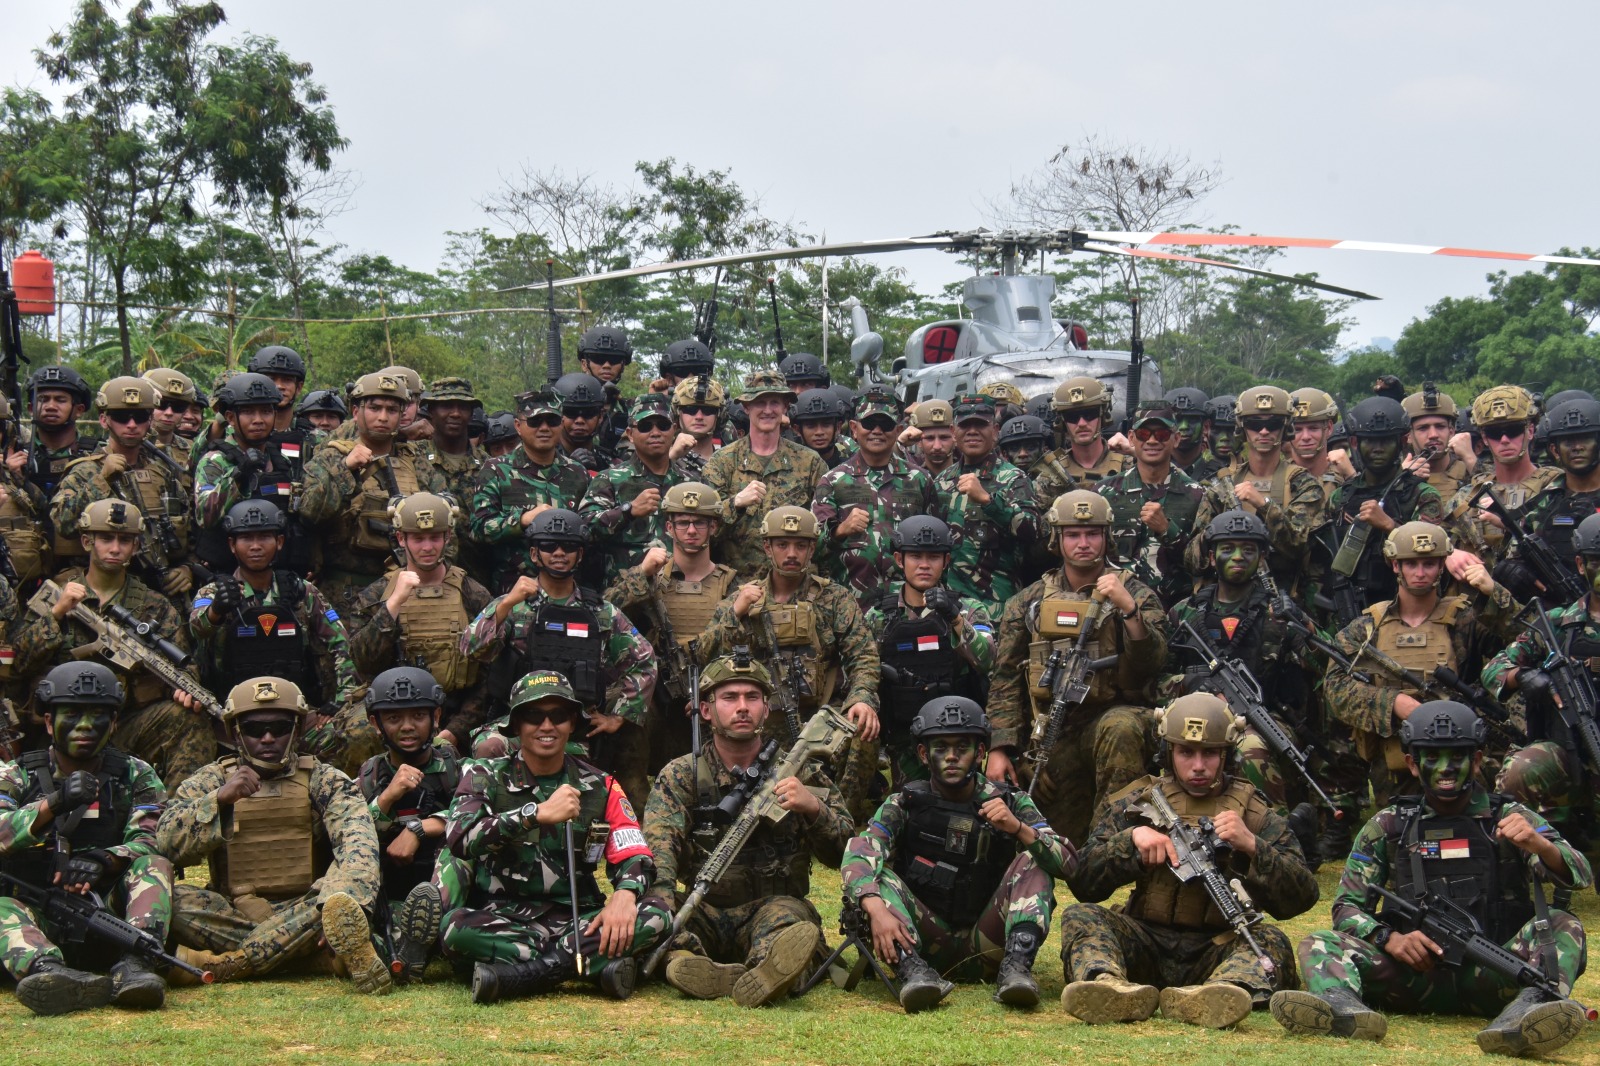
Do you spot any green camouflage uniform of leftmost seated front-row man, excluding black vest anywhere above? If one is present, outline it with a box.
[0,749,173,980]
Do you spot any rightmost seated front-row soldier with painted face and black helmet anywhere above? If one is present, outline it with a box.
[1272,699,1592,1056]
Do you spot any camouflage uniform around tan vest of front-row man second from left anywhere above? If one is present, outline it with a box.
[155,759,381,976]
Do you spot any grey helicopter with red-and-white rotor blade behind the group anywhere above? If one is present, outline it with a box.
[501,229,1600,424]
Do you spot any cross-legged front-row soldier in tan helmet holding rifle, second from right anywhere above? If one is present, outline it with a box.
[1061,693,1318,1029]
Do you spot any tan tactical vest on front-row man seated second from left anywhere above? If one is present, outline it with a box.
[210,755,328,900]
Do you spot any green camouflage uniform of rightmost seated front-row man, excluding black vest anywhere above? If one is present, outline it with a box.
[1298,786,1594,1018]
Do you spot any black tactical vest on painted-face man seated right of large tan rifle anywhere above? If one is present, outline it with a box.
[894,781,1018,930]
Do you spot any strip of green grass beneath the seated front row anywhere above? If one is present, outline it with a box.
[0,868,1600,1066]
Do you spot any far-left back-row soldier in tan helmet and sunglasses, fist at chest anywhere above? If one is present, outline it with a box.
[50,378,197,603]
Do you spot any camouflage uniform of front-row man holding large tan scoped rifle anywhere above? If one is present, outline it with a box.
[645,744,851,968]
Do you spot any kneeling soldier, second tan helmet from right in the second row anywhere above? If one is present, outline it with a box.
[986,490,1166,840]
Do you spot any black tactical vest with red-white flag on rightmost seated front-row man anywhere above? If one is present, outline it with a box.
[1389,795,1533,944]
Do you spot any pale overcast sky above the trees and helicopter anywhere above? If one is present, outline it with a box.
[0,0,1600,344]
